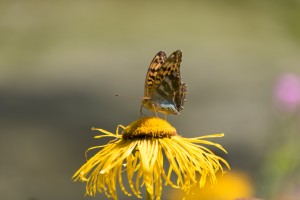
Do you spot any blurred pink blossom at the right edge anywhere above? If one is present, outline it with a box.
[274,73,300,111]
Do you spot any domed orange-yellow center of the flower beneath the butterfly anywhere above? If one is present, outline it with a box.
[122,117,177,140]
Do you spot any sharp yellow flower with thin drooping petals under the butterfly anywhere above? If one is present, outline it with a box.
[73,117,229,199]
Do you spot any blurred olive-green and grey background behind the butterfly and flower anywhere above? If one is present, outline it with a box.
[0,0,300,200]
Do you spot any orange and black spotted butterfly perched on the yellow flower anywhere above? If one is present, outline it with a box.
[141,50,187,115]
